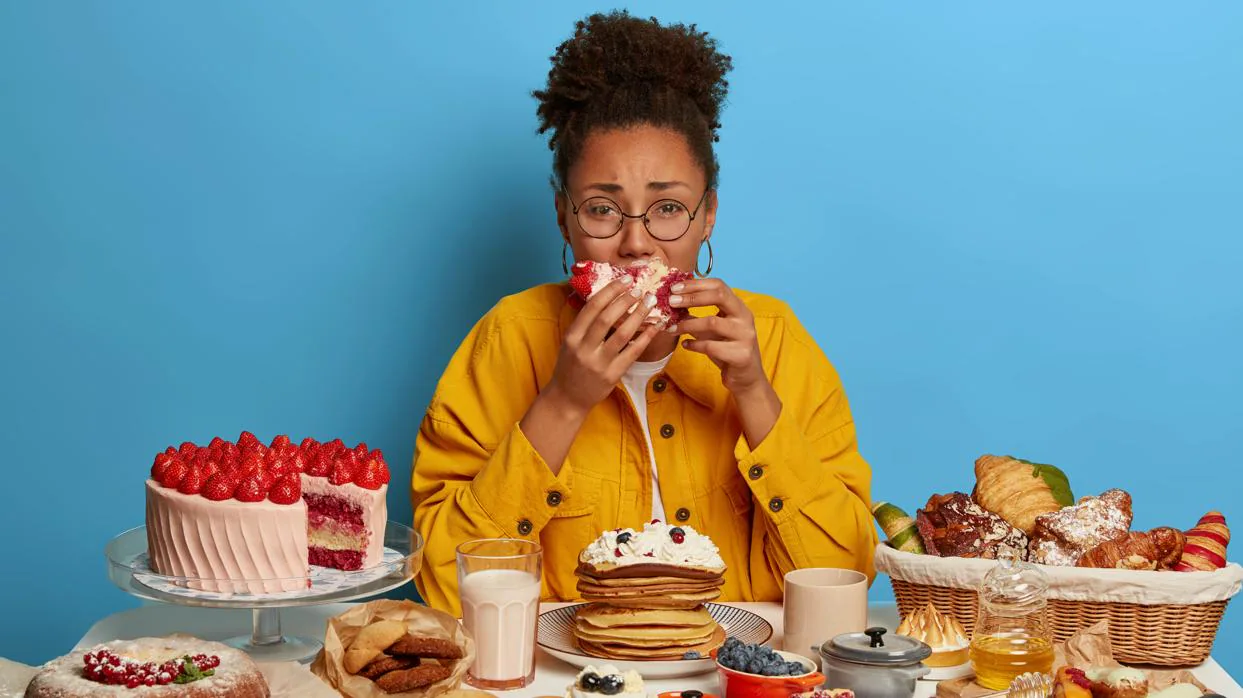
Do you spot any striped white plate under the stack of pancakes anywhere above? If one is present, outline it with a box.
[536,604,773,678]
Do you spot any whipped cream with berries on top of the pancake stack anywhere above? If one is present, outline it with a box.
[582,522,725,570]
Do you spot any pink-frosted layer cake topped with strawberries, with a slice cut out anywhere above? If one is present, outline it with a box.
[147,431,389,594]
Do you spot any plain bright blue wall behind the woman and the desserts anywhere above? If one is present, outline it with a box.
[0,1,1243,674]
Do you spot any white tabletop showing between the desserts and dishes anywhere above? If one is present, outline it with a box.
[75,602,1243,698]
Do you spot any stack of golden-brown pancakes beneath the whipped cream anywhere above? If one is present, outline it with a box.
[574,531,725,659]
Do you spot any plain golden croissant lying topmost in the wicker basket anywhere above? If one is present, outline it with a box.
[971,456,1074,535]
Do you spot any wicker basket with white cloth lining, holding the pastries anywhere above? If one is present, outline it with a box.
[876,543,1243,667]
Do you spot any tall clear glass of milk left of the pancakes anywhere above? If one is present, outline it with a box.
[457,538,543,691]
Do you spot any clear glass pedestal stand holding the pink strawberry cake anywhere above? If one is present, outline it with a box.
[104,522,423,663]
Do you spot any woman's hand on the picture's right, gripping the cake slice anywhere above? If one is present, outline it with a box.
[669,278,769,396]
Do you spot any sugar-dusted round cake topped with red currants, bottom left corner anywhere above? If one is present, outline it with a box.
[26,637,270,698]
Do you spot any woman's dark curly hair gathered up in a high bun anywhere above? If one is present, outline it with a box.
[533,10,732,184]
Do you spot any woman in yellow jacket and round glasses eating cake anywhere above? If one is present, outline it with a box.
[413,12,876,612]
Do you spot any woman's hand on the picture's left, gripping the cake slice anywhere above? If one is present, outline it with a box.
[548,277,664,416]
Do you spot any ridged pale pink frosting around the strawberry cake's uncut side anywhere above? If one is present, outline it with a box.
[147,479,310,594]
